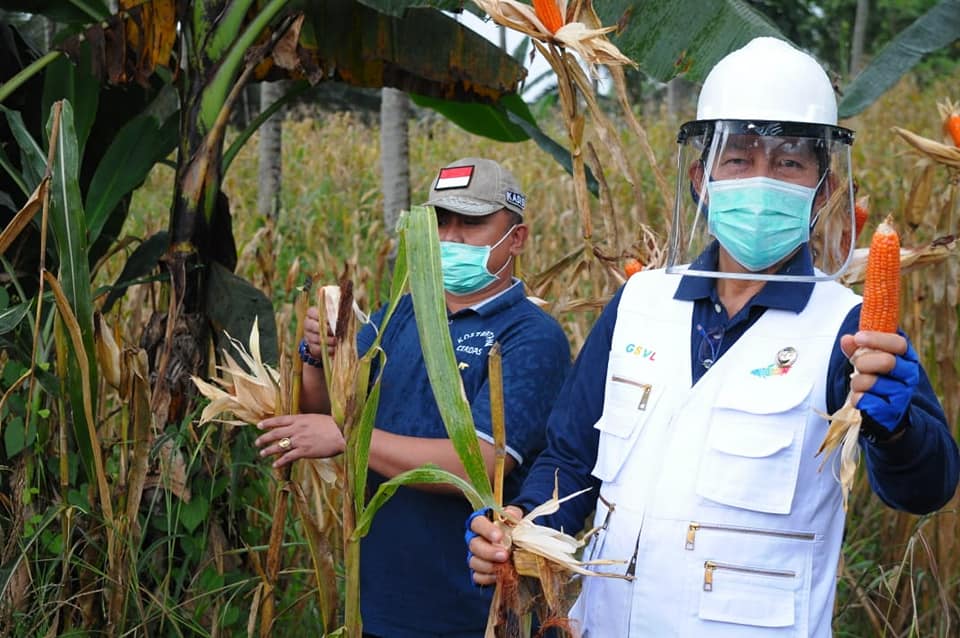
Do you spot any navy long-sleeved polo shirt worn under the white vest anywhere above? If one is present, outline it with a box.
[514,242,960,533]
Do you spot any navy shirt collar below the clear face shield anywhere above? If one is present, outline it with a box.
[673,240,814,312]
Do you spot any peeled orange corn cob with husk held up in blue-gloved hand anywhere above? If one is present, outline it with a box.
[817,216,900,510]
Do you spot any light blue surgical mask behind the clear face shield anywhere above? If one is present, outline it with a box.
[707,177,817,272]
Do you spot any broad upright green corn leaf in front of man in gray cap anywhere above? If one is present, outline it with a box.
[400,206,493,505]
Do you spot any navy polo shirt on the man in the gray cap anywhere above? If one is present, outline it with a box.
[357,281,570,638]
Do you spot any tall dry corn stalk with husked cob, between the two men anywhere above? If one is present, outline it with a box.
[474,0,660,313]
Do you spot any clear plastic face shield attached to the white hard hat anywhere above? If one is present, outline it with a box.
[667,120,856,281]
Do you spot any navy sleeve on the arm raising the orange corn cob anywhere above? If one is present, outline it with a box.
[827,306,960,514]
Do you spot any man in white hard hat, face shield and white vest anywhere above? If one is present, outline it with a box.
[469,38,960,638]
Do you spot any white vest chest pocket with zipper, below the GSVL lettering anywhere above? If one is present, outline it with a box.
[593,355,666,481]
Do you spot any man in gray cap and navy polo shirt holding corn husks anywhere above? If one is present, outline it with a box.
[257,157,570,638]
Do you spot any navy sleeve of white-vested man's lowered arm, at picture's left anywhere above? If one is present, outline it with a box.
[514,288,623,534]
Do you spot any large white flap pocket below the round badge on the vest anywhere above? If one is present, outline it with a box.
[696,379,813,514]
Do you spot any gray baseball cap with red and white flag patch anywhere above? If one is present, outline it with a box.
[427,157,527,217]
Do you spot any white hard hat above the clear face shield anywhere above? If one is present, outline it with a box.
[697,38,837,126]
